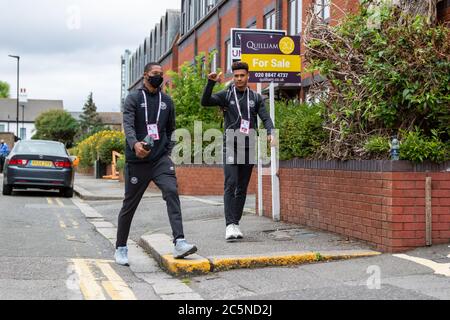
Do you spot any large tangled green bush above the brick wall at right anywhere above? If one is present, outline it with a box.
[305,1,450,161]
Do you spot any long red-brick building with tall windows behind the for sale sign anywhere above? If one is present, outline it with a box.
[119,0,450,106]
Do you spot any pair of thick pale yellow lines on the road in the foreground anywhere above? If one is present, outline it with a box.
[71,259,137,300]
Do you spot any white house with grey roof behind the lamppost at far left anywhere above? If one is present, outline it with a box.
[0,99,64,140]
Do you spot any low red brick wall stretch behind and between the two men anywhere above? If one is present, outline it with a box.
[176,166,258,196]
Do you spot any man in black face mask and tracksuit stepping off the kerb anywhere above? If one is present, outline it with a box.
[115,63,197,265]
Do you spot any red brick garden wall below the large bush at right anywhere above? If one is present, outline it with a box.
[263,168,450,252]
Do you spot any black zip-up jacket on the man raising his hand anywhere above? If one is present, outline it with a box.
[201,80,275,138]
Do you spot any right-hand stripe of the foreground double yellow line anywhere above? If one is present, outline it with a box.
[96,261,137,300]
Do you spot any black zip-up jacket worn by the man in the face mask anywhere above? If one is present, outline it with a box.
[123,87,176,163]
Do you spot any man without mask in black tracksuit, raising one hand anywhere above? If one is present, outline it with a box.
[202,62,275,241]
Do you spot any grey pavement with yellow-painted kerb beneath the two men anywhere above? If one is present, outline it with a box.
[74,174,380,277]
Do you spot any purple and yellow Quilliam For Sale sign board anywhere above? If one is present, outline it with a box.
[241,34,302,83]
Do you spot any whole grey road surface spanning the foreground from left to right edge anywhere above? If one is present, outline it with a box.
[0,174,450,300]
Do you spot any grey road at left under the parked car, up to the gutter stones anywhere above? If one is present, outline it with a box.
[0,176,159,300]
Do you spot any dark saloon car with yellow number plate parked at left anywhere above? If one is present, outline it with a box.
[3,140,76,198]
